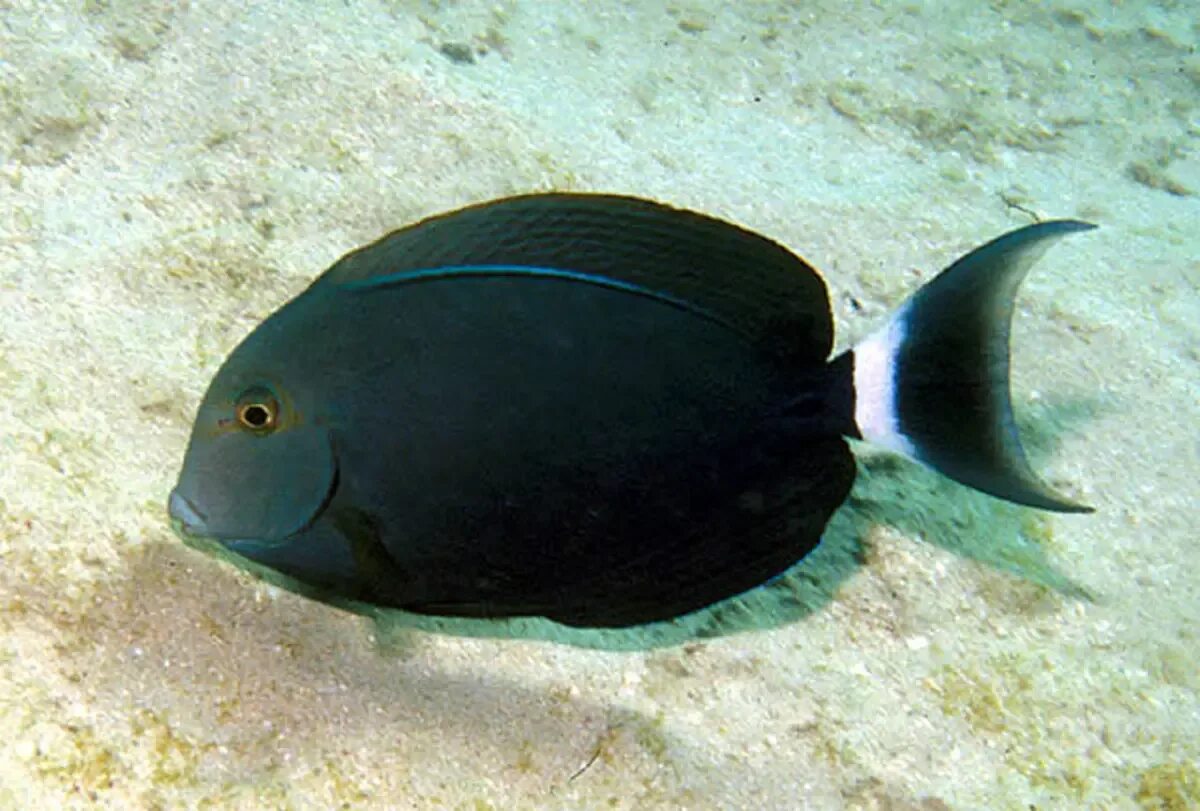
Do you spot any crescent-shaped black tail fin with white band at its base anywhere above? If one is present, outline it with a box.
[853,220,1094,512]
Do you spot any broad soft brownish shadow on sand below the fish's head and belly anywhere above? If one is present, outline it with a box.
[39,540,692,795]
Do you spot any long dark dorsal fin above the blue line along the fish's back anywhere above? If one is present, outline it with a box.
[316,193,833,365]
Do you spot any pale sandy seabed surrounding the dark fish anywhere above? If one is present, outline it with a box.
[0,0,1200,811]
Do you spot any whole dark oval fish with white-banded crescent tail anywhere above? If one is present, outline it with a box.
[168,193,1094,629]
